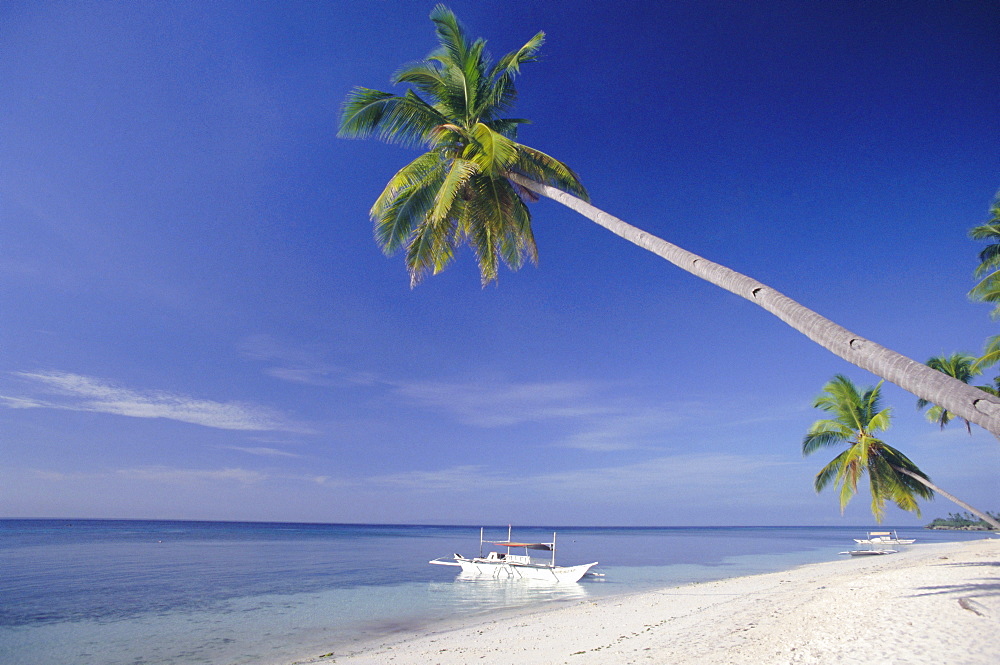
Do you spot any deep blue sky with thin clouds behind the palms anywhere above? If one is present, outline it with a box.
[0,1,1000,525]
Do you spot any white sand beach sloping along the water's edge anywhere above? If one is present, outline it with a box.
[308,538,1000,665]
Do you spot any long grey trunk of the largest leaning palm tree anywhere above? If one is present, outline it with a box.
[508,173,1000,438]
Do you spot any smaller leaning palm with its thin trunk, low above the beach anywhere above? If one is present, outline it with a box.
[802,374,1000,530]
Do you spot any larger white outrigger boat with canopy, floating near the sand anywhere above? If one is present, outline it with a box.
[429,526,597,582]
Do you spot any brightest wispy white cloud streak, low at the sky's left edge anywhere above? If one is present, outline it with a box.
[0,371,304,432]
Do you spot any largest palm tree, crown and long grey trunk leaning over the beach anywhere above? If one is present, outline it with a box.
[340,5,1000,434]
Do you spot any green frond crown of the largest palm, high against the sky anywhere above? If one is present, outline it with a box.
[339,5,587,285]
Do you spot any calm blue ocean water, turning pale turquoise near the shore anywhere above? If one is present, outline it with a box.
[0,520,982,665]
